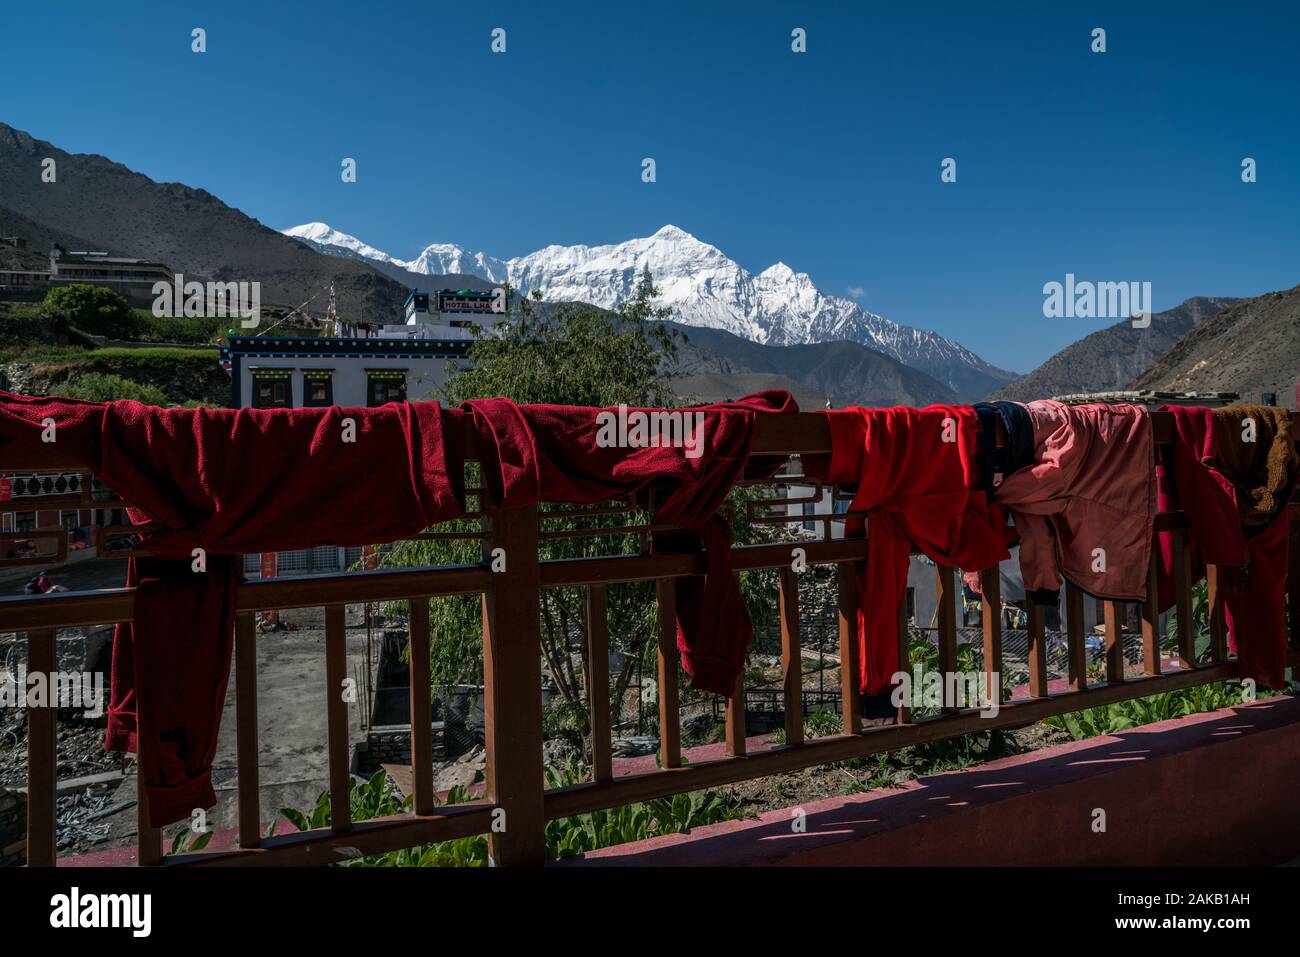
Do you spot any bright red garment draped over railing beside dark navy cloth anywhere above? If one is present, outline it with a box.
[803,406,1010,694]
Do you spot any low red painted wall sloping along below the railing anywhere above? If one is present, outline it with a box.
[567,698,1300,866]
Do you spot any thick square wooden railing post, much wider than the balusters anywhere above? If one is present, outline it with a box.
[482,503,546,867]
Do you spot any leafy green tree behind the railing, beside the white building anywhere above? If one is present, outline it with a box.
[385,272,772,736]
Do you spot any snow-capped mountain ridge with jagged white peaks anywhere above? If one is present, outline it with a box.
[283,222,1015,397]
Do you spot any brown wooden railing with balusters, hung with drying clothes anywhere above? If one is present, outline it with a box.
[0,413,1300,866]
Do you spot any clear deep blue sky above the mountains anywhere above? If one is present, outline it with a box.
[0,0,1300,371]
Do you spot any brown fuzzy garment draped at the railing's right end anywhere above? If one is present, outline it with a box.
[1213,406,1300,525]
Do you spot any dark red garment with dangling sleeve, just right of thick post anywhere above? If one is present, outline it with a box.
[463,391,798,696]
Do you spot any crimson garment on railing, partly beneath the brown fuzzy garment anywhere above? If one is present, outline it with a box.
[1157,406,1288,688]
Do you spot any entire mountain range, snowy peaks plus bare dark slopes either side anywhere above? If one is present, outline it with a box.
[0,117,1300,406]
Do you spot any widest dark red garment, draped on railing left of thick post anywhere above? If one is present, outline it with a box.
[0,393,463,826]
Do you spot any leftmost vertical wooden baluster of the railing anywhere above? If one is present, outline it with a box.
[18,628,55,867]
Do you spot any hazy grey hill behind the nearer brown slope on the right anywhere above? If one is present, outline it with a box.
[989,296,1238,402]
